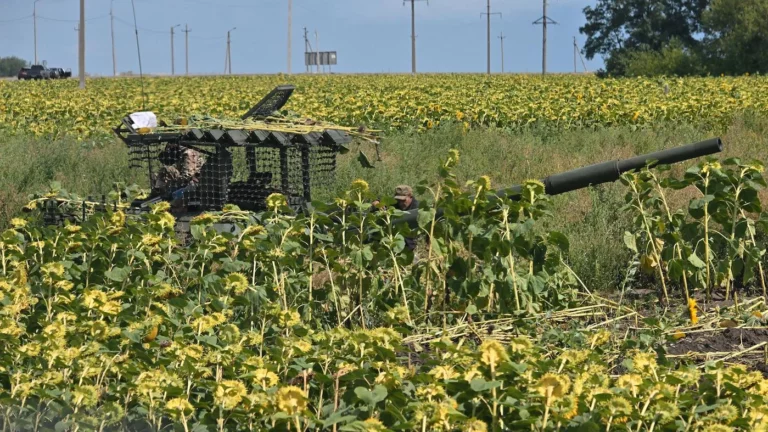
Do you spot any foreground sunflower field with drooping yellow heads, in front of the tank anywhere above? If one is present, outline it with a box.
[0,146,768,432]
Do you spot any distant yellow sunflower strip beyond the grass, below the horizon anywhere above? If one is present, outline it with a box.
[0,75,768,138]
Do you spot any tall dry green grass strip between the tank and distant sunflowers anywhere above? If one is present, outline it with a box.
[0,116,768,289]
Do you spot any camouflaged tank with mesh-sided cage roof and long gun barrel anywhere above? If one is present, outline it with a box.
[31,85,723,233]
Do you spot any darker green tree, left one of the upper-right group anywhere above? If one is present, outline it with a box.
[579,0,712,74]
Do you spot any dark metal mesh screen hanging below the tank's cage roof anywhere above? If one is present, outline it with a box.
[129,138,337,211]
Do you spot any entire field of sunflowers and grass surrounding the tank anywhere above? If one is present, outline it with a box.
[0,76,768,432]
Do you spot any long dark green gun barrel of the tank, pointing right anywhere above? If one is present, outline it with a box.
[393,138,723,226]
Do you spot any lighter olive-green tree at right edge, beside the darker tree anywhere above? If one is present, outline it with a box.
[702,0,768,75]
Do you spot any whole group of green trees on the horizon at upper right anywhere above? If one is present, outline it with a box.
[579,0,768,76]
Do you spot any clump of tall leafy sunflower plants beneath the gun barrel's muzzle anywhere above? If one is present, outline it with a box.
[622,158,768,304]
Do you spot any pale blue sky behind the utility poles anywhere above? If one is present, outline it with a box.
[0,0,603,75]
